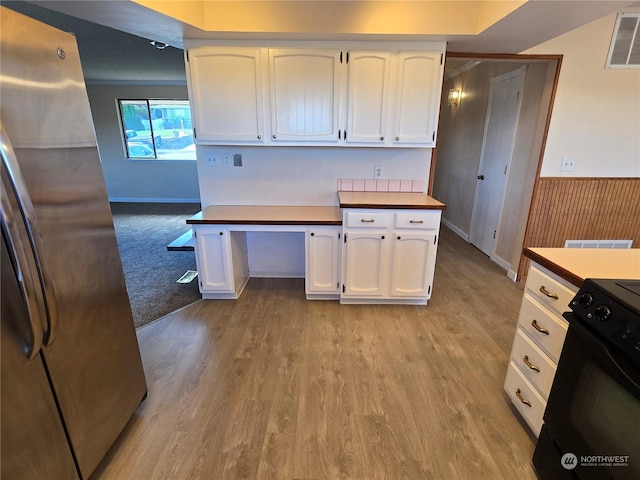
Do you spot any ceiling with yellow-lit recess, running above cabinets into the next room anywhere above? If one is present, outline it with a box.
[2,0,640,83]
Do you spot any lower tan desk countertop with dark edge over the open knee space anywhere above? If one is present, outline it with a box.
[187,205,342,225]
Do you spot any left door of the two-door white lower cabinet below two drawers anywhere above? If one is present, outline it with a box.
[343,231,391,297]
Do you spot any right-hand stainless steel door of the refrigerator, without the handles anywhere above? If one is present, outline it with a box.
[0,7,146,478]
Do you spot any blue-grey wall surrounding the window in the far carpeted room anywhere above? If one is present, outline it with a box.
[87,85,200,203]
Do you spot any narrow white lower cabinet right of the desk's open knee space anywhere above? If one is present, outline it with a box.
[305,226,342,300]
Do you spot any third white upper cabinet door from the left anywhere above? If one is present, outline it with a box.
[345,51,391,145]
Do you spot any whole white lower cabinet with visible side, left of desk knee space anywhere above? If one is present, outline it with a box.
[193,225,249,299]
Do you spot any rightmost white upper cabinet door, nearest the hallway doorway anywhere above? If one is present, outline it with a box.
[393,51,443,147]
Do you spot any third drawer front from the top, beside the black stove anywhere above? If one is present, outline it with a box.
[511,329,556,400]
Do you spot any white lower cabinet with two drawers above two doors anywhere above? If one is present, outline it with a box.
[340,209,440,304]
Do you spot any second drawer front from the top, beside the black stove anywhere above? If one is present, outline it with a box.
[518,293,567,363]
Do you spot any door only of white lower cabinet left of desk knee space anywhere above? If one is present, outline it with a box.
[194,226,234,293]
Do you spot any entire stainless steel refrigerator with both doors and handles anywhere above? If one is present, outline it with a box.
[0,7,147,480]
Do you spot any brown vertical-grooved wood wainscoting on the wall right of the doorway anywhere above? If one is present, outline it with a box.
[518,177,640,278]
